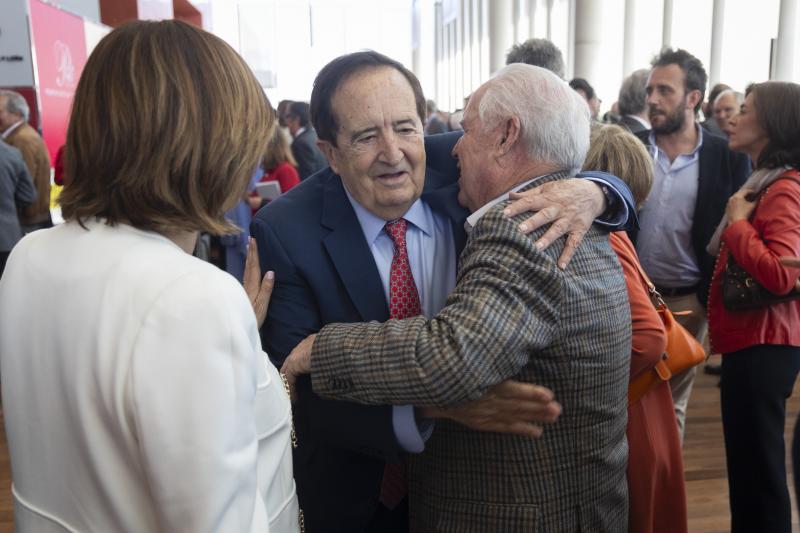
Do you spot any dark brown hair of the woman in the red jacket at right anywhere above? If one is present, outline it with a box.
[747,81,800,169]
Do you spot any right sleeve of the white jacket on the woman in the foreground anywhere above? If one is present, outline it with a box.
[128,272,269,533]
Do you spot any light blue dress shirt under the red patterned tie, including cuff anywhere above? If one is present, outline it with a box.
[345,188,458,453]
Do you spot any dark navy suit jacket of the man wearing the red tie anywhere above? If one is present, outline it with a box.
[250,132,633,533]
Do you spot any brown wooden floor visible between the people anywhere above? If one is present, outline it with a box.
[0,358,800,533]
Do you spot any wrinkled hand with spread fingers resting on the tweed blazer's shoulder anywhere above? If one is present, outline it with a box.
[505,179,606,268]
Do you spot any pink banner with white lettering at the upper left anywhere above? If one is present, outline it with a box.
[29,0,86,161]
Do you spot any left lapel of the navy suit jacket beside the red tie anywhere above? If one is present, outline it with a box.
[320,172,389,322]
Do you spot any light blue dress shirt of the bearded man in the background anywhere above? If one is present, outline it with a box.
[636,126,703,289]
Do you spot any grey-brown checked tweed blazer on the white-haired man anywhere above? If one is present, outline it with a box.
[312,175,631,533]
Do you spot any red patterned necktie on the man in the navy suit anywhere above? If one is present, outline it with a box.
[380,218,420,509]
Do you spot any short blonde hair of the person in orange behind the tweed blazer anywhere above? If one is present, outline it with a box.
[583,124,653,208]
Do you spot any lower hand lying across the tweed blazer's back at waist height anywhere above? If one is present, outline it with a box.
[420,380,561,439]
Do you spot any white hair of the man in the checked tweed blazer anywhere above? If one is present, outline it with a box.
[478,63,590,172]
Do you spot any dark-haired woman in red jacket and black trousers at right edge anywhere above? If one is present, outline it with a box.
[708,82,800,533]
